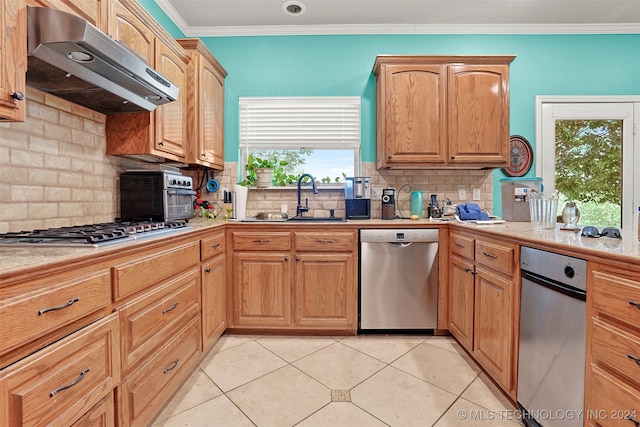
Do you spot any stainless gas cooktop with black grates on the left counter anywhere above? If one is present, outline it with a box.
[0,221,189,247]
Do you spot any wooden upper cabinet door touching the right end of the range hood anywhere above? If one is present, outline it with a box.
[155,39,187,160]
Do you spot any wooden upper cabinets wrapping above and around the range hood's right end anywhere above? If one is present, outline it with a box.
[106,0,190,162]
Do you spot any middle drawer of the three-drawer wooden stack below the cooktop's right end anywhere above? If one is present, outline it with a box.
[117,269,200,372]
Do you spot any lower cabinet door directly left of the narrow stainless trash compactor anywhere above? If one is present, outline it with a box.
[473,267,514,390]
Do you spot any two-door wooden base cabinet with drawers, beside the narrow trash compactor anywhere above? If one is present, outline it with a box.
[449,231,520,400]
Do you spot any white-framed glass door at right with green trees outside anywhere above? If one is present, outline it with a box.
[536,97,640,231]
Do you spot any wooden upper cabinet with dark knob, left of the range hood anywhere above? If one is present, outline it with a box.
[0,0,27,122]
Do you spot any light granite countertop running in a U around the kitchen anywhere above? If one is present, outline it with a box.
[0,219,640,280]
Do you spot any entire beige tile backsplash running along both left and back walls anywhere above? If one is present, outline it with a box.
[0,88,493,233]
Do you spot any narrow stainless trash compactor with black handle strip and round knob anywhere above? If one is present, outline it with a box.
[518,246,587,427]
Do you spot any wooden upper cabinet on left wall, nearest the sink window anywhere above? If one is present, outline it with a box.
[178,39,227,170]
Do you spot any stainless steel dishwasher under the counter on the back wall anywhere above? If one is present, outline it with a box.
[358,229,438,333]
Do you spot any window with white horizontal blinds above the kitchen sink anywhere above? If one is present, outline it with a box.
[238,97,360,185]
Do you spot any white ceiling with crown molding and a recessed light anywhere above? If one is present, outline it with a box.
[155,0,640,37]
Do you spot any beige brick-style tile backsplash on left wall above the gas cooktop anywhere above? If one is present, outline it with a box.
[0,87,148,233]
